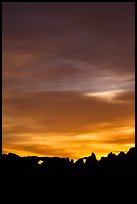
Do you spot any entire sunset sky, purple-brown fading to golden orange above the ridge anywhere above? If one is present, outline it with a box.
[2,2,135,159]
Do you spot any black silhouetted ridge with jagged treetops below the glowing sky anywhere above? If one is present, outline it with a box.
[1,148,136,204]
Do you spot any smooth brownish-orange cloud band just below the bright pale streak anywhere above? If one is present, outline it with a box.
[3,92,134,136]
